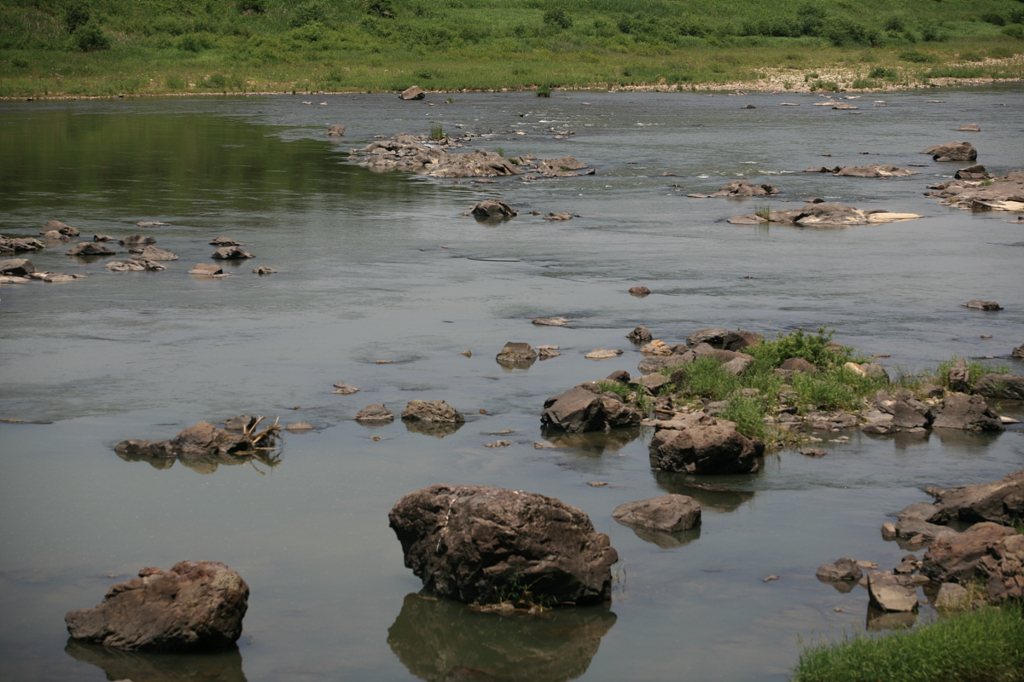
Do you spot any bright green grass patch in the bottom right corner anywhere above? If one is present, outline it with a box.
[791,605,1024,682]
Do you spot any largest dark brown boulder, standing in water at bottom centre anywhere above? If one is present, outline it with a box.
[388,485,618,605]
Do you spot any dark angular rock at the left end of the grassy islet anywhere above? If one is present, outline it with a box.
[541,382,640,433]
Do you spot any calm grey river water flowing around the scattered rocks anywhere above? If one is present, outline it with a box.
[0,86,1024,682]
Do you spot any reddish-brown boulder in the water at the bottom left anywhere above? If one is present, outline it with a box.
[65,561,249,651]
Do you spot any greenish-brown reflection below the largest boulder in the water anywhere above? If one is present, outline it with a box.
[387,594,615,682]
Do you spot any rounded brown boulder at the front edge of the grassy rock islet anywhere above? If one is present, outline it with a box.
[649,413,765,474]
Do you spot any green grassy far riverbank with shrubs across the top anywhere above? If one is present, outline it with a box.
[0,0,1024,97]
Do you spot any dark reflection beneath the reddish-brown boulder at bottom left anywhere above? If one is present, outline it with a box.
[65,639,246,682]
